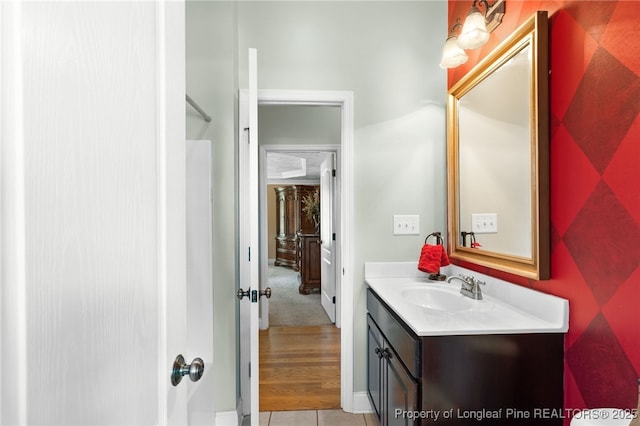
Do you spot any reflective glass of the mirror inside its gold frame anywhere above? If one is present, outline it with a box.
[458,45,532,257]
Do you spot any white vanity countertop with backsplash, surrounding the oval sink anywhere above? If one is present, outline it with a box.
[365,262,569,336]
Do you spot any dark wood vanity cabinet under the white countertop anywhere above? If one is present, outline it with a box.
[367,289,564,426]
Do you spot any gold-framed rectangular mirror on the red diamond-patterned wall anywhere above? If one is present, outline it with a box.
[447,11,550,280]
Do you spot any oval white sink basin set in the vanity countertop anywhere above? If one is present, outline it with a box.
[402,285,474,312]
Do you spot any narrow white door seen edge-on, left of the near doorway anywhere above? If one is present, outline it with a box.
[238,49,261,426]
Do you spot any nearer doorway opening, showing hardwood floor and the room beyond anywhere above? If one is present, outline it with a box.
[259,105,341,411]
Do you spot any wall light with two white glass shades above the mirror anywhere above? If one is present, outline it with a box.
[440,0,506,68]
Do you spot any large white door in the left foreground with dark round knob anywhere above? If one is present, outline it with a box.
[0,1,194,425]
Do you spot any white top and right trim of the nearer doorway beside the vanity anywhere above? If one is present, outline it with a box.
[239,90,356,412]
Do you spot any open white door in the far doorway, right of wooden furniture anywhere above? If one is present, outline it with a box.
[320,153,336,322]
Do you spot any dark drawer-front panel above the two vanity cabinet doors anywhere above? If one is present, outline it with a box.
[367,288,421,378]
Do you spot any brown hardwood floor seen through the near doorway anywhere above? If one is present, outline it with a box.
[260,325,340,411]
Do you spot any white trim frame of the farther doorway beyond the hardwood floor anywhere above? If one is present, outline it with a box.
[258,144,342,330]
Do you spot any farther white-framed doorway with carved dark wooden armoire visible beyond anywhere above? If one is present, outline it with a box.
[260,145,342,329]
